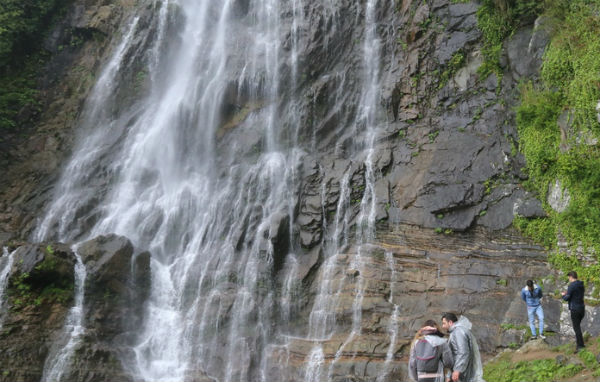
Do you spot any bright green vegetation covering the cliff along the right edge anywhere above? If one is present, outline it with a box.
[514,0,600,283]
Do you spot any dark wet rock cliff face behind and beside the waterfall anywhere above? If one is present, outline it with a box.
[0,0,598,381]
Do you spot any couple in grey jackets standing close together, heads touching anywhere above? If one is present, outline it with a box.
[408,313,485,382]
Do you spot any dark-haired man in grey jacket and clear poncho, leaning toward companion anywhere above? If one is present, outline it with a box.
[442,313,485,382]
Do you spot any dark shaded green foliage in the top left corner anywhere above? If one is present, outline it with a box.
[0,0,68,131]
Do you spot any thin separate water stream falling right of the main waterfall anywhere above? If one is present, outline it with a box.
[307,0,380,381]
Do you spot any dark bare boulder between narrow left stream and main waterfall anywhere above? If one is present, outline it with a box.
[65,235,150,381]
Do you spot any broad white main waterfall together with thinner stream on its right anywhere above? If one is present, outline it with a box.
[35,0,396,382]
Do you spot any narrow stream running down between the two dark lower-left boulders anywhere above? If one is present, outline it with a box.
[42,247,86,382]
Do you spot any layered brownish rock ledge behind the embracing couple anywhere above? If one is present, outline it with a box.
[273,225,564,381]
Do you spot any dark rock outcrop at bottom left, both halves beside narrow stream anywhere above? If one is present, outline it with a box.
[0,235,150,382]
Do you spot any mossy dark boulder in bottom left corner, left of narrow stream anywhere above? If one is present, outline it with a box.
[0,243,75,381]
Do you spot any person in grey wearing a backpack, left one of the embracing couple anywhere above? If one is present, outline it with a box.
[408,320,454,382]
